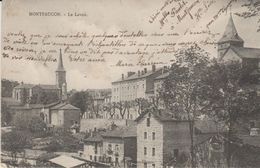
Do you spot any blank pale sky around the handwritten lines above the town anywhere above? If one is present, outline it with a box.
[1,0,260,90]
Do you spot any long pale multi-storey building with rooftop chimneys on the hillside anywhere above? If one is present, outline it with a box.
[111,65,163,102]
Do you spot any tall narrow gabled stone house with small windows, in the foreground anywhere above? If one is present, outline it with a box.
[136,111,190,168]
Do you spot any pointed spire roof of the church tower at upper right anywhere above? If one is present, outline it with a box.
[218,14,244,43]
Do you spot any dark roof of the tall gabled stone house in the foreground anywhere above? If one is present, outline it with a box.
[135,110,188,122]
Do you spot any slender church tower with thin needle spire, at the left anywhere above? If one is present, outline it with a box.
[56,49,67,100]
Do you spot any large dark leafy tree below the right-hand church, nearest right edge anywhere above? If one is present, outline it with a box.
[203,61,260,166]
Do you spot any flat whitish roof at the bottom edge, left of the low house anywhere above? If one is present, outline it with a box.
[49,155,86,168]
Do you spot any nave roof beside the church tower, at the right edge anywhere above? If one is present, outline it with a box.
[230,46,260,59]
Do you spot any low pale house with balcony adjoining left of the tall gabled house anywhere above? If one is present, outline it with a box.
[82,126,137,168]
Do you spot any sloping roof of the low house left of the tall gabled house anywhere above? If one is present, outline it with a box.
[102,125,137,138]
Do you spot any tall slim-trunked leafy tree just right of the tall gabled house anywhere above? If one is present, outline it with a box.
[159,45,209,168]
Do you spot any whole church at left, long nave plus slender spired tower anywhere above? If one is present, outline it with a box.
[12,48,67,104]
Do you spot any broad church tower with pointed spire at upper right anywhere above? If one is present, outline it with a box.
[218,14,244,58]
